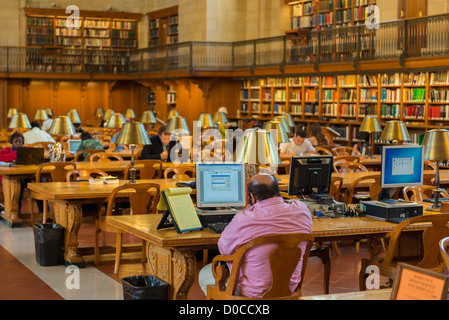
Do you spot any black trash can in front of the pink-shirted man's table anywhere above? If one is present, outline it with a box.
[122,275,168,300]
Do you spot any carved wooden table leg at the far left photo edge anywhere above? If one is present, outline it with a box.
[2,176,22,227]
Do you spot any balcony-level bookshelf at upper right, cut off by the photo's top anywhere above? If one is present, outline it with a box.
[285,0,376,30]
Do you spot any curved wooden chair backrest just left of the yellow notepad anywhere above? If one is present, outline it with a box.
[99,183,161,218]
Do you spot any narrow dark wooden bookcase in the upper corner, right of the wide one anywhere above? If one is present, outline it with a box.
[147,6,178,47]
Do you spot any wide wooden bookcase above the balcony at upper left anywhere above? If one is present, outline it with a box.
[25,8,142,73]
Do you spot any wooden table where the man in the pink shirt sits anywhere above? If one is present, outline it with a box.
[107,215,420,299]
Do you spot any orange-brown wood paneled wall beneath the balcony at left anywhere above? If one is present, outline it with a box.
[0,78,240,129]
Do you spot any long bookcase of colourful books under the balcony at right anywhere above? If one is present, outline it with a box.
[242,71,449,150]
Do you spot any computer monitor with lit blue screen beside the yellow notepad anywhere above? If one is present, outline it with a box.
[195,163,246,209]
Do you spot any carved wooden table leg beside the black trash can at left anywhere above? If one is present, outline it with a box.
[55,200,86,267]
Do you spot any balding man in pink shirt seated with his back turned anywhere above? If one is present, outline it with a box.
[199,174,312,298]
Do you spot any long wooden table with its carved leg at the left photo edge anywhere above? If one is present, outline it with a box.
[0,161,195,227]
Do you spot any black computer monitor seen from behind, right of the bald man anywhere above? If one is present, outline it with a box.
[288,156,333,196]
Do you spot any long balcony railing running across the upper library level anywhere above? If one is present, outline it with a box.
[0,14,449,74]
